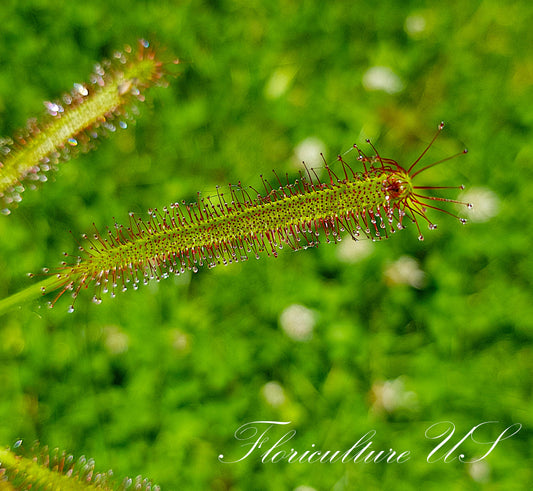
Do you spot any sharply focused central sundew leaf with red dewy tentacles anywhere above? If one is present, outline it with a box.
[21,123,472,312]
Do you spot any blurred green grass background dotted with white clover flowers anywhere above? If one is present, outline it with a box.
[0,0,533,491]
